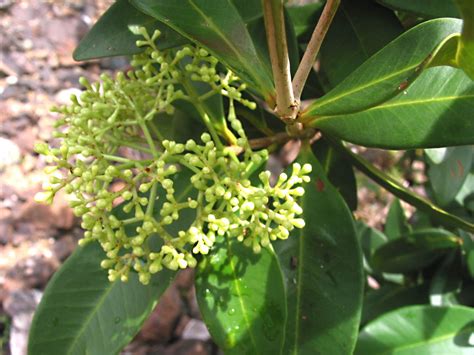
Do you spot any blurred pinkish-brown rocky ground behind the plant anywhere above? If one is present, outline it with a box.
[0,0,412,355]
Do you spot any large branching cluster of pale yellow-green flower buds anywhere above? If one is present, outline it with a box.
[36,28,311,284]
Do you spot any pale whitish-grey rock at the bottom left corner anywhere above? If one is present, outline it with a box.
[4,290,42,355]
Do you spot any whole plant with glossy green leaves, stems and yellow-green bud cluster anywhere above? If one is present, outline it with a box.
[29,0,474,355]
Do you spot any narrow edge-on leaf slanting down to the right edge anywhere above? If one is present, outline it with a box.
[326,137,474,232]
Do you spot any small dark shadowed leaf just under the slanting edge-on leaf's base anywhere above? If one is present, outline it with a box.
[312,138,357,211]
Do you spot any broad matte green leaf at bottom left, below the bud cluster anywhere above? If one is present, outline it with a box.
[28,243,174,355]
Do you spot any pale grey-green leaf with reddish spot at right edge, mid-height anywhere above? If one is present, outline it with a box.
[428,146,474,206]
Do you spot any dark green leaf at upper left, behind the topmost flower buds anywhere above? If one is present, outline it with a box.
[73,0,188,60]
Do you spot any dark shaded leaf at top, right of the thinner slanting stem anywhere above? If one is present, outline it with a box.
[318,0,403,89]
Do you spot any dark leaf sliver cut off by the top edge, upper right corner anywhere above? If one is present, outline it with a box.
[377,0,460,18]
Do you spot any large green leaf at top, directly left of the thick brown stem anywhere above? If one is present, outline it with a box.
[132,0,274,99]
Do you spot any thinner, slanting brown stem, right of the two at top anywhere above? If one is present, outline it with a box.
[293,0,341,102]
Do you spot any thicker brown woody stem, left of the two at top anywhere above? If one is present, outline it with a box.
[262,0,298,121]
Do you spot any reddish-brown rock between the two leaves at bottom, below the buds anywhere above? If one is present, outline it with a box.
[137,285,181,344]
